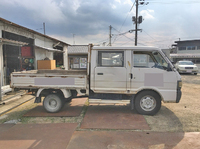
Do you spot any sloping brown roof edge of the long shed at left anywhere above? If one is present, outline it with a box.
[0,17,69,45]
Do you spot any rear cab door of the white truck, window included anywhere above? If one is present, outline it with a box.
[94,51,127,93]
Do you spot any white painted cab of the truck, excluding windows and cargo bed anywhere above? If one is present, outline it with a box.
[90,47,181,102]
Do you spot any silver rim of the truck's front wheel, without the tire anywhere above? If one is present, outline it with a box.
[140,96,156,111]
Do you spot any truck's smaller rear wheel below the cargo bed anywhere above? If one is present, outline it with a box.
[43,94,64,113]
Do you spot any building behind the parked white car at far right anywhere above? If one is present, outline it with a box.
[170,40,200,64]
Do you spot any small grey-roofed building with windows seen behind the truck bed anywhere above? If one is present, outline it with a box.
[67,45,89,70]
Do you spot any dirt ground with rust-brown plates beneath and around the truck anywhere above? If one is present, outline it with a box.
[0,75,200,149]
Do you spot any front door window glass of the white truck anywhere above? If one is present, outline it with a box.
[133,53,155,68]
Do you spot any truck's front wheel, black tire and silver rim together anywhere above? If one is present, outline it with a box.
[135,91,161,115]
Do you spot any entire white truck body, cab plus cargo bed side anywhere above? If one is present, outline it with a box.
[11,47,181,102]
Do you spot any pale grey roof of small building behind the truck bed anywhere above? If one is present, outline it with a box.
[67,45,88,54]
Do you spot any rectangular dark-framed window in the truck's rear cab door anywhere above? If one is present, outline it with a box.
[98,51,124,67]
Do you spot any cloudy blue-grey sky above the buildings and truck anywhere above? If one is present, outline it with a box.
[0,0,200,48]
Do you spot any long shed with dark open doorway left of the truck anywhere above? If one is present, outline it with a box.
[0,18,69,94]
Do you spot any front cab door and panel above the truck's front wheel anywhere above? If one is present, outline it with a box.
[131,51,177,101]
